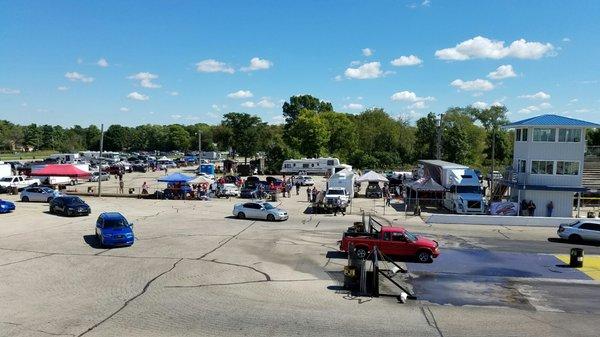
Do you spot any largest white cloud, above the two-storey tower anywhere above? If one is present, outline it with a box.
[435,36,554,61]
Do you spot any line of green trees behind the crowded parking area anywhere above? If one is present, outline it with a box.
[0,95,572,172]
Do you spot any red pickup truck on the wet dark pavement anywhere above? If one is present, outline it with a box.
[340,226,440,263]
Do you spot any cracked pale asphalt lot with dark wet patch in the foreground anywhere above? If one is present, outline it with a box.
[0,175,600,336]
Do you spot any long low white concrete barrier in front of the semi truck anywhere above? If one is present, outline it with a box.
[425,214,577,227]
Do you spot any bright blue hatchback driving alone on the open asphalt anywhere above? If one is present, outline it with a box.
[96,212,134,247]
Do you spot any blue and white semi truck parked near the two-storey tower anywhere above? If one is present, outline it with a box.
[418,160,486,214]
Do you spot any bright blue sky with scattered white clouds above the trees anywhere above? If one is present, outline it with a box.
[0,0,600,126]
